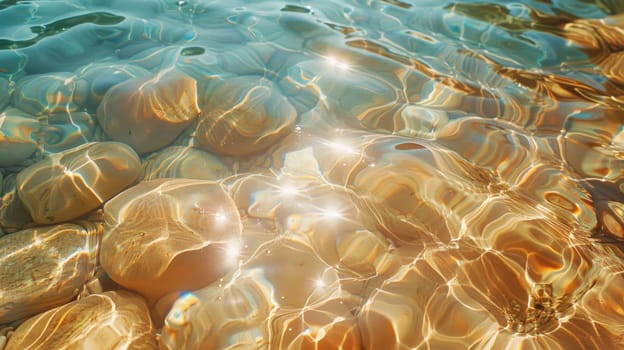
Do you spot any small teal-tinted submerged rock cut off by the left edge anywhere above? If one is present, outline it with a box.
[0,108,40,167]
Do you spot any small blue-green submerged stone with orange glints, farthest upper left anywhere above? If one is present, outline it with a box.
[13,72,87,115]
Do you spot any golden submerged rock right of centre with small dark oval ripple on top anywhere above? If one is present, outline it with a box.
[314,132,482,245]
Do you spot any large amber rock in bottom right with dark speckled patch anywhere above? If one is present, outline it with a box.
[358,241,622,349]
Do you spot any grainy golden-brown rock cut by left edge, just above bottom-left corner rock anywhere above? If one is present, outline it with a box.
[0,224,102,324]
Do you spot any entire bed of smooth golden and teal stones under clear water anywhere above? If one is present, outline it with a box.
[0,0,624,350]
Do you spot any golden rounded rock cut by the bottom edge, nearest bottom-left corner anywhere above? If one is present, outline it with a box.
[5,291,157,350]
